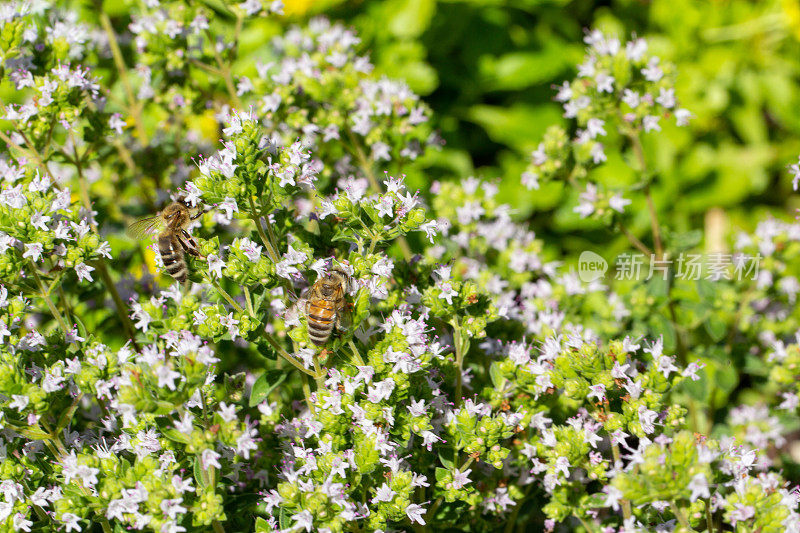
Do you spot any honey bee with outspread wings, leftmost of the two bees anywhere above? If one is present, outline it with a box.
[125,200,205,283]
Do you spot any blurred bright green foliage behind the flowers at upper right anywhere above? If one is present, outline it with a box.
[285,0,800,255]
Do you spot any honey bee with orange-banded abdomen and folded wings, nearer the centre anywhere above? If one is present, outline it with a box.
[301,265,352,346]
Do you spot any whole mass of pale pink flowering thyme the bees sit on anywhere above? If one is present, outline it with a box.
[0,1,800,533]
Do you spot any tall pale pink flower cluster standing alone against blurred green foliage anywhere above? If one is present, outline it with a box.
[522,30,691,219]
